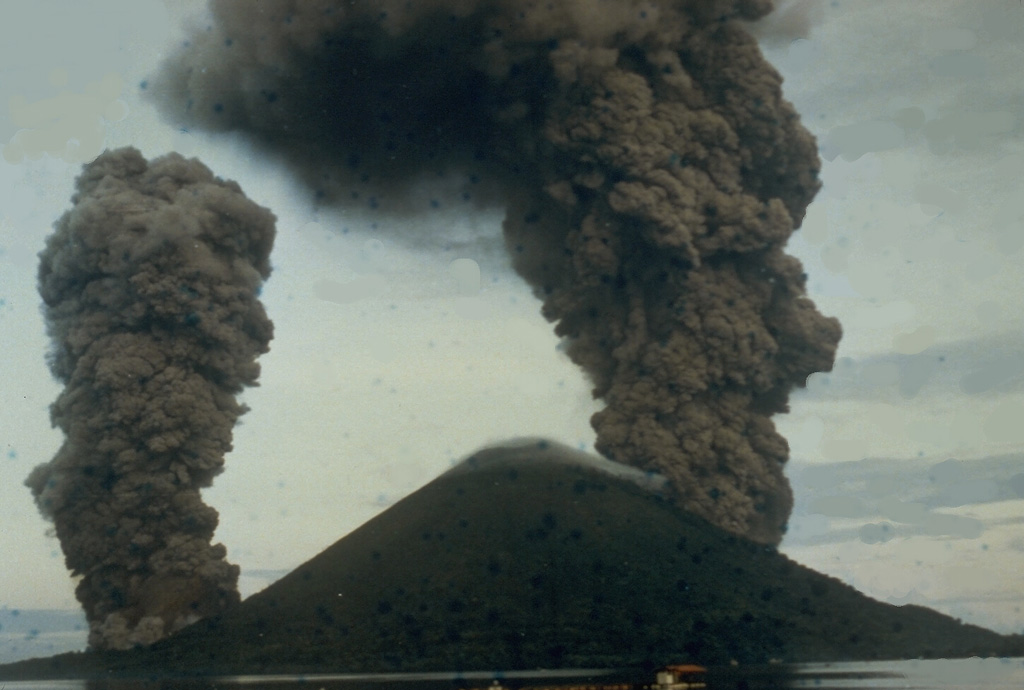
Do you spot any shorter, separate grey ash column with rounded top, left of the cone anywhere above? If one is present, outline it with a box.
[26,148,274,649]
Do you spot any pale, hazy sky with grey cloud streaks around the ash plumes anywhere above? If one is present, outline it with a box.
[0,0,1024,655]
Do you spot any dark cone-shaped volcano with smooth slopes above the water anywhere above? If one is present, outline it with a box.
[2,444,1020,673]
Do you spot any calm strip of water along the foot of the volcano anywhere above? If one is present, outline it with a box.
[6,658,1024,690]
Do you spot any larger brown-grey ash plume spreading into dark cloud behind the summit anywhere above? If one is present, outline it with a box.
[146,0,841,544]
